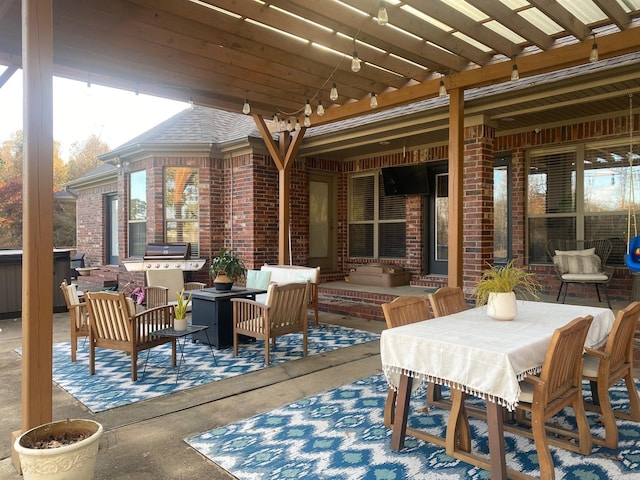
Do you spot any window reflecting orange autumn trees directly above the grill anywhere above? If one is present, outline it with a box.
[164,167,200,257]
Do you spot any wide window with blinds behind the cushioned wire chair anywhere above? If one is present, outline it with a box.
[527,144,640,265]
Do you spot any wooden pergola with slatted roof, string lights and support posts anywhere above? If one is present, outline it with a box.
[0,0,640,464]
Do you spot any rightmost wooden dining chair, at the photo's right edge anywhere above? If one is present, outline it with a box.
[582,302,640,448]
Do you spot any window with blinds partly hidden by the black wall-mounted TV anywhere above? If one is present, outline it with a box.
[349,173,406,258]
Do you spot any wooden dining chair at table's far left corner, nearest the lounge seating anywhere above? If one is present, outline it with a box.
[382,295,432,428]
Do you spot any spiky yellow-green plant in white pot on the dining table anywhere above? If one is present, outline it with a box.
[476,260,541,320]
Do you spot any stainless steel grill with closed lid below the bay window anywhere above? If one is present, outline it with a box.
[123,242,206,272]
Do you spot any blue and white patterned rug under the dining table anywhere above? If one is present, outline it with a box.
[185,374,640,480]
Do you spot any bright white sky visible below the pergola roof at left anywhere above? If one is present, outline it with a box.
[0,67,189,160]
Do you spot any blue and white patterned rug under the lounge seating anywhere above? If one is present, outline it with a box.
[36,324,380,412]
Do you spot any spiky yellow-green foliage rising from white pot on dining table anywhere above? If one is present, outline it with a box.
[476,260,541,306]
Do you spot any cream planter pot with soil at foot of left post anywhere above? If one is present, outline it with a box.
[14,420,102,480]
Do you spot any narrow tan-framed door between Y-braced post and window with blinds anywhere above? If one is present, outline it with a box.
[309,172,338,272]
